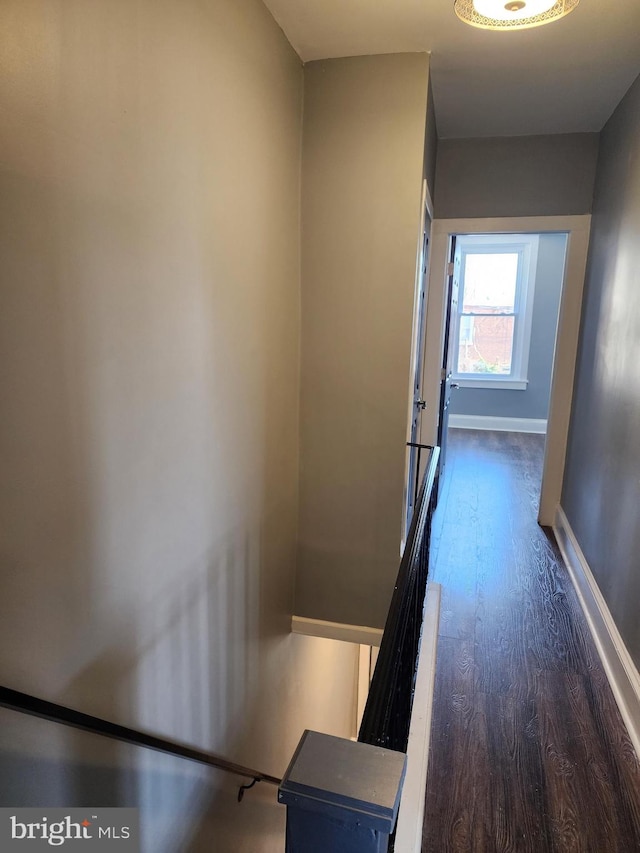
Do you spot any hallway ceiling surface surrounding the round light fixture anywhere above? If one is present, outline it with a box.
[265,0,640,138]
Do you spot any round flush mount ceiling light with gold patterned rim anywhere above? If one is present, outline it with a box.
[453,0,580,30]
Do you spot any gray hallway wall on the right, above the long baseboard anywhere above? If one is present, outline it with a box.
[562,73,640,666]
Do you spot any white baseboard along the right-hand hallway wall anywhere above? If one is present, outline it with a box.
[553,507,640,757]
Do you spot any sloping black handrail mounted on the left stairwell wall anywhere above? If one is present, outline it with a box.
[0,687,282,802]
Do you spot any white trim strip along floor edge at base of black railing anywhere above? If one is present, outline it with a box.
[394,581,441,853]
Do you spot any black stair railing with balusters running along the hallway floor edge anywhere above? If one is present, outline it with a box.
[358,447,440,752]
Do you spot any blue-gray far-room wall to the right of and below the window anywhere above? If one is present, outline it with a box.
[451,234,567,419]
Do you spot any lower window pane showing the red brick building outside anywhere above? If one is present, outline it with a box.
[456,314,515,376]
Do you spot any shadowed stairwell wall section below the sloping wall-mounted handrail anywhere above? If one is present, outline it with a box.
[0,710,285,853]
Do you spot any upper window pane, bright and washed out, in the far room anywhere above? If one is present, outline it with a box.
[462,252,518,314]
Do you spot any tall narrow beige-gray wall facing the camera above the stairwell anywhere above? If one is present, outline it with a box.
[296,54,429,627]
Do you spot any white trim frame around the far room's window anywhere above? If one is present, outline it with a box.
[452,234,539,391]
